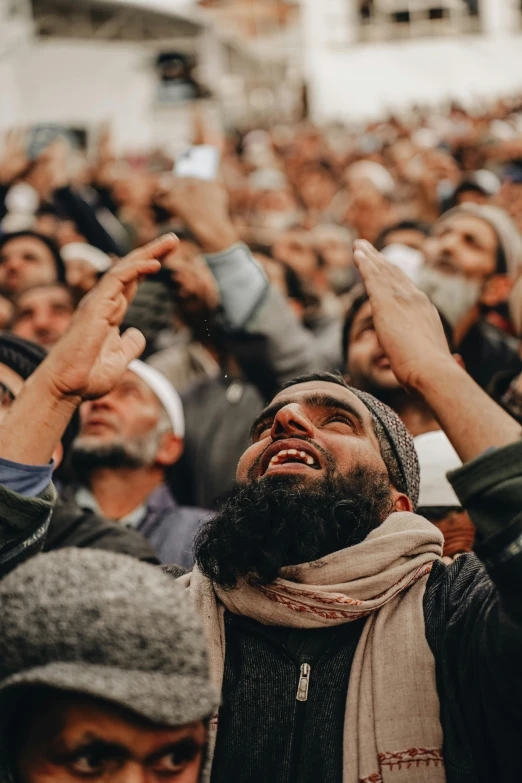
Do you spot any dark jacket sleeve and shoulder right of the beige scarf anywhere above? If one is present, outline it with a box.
[424,442,522,783]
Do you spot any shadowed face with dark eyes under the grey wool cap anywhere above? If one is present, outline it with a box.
[15,692,206,783]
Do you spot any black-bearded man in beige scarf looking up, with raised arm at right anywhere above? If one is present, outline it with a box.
[181,241,522,783]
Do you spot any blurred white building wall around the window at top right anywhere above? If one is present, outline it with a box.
[302,0,522,122]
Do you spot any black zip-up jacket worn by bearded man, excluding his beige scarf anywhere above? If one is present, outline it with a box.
[212,442,522,783]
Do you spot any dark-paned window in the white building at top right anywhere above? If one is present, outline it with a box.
[358,0,480,41]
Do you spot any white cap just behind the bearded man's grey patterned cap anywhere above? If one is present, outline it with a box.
[414,430,462,507]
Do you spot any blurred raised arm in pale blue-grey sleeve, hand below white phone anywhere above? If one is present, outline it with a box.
[154,179,331,396]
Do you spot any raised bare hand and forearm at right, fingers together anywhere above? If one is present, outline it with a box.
[354,240,522,462]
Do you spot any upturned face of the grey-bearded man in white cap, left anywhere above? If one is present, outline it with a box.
[73,370,182,469]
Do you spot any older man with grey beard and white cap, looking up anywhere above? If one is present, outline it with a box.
[72,360,208,567]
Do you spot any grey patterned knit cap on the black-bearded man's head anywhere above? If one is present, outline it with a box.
[348,386,420,509]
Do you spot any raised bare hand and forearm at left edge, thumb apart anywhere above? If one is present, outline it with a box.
[0,234,178,465]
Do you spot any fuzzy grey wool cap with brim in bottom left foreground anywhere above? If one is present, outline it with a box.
[0,549,219,726]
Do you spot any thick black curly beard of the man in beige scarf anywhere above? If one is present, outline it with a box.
[195,468,393,588]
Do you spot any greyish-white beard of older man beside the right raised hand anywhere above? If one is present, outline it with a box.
[417,266,482,326]
